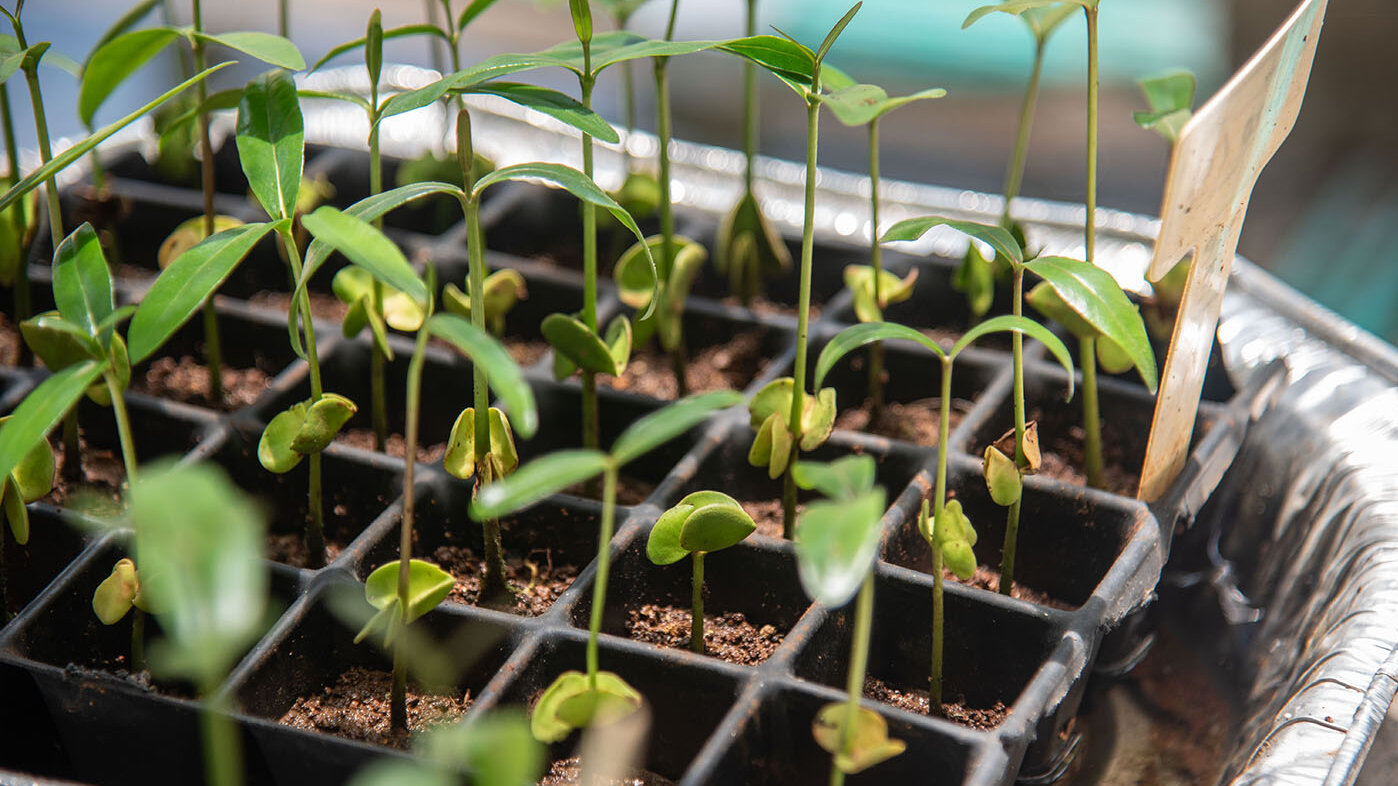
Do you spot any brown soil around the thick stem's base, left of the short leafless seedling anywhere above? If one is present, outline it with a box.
[432,545,577,617]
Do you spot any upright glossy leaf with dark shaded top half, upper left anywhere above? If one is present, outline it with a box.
[236,70,305,221]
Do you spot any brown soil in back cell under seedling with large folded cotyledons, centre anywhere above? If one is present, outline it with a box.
[598,331,768,400]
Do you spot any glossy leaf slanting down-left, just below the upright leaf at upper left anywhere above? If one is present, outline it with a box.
[127,224,271,364]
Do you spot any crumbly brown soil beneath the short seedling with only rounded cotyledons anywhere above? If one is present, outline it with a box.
[626,603,784,666]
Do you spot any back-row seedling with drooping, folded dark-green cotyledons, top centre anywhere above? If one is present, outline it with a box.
[714,0,791,308]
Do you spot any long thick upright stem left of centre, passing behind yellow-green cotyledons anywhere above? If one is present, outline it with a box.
[456,106,509,597]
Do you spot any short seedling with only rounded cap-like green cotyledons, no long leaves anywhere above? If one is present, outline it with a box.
[646,491,758,653]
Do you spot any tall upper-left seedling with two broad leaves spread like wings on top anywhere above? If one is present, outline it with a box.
[78,0,306,401]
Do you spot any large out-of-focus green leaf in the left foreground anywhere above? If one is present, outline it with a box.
[130,462,270,685]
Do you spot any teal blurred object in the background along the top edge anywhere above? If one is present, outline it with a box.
[762,0,1227,95]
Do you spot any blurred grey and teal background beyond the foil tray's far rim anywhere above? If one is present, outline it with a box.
[15,0,1398,341]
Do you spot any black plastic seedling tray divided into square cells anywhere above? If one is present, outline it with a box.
[0,128,1258,786]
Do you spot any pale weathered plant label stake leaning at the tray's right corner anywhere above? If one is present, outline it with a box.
[1137,0,1327,502]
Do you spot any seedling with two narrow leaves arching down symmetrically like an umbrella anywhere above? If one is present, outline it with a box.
[816,313,1072,712]
